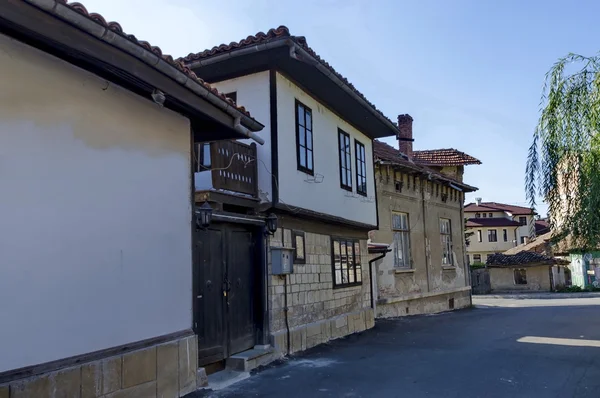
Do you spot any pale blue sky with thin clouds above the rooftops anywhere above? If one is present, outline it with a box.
[82,0,600,213]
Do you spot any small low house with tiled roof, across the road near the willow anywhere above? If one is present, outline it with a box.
[486,251,569,293]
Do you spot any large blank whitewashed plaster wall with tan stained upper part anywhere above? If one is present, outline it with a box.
[0,35,192,372]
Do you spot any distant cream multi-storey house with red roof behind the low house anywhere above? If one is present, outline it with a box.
[465,198,536,264]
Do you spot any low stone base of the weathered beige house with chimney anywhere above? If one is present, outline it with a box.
[376,290,471,318]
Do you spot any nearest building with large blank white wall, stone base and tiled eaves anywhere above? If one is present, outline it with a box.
[0,0,262,398]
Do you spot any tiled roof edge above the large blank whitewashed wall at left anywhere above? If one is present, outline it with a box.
[42,0,250,116]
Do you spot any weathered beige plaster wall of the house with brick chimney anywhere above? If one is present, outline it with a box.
[371,167,468,316]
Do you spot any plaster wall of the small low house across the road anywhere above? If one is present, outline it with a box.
[489,265,550,292]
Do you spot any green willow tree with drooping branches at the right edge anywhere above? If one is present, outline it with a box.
[525,54,600,250]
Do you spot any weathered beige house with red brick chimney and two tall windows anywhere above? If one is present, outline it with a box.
[371,115,476,317]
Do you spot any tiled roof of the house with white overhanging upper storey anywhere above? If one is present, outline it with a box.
[177,25,396,125]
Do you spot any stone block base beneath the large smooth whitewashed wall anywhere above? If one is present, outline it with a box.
[0,335,198,398]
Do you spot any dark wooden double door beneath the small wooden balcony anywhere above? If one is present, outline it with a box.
[194,224,259,366]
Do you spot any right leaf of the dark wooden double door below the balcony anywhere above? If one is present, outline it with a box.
[226,228,256,355]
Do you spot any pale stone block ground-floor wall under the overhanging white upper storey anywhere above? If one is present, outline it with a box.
[268,228,374,353]
